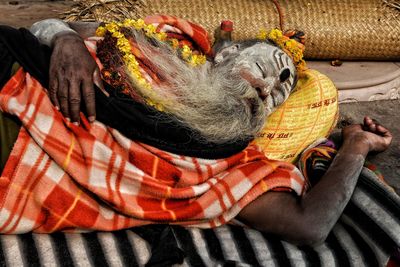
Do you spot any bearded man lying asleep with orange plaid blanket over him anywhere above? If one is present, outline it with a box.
[0,18,392,248]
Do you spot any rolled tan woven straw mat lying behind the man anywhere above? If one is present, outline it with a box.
[64,0,400,60]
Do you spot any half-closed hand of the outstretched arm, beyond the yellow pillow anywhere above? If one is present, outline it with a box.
[343,117,392,152]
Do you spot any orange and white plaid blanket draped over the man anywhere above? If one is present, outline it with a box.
[0,69,304,234]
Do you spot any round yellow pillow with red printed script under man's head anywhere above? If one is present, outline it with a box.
[253,69,339,162]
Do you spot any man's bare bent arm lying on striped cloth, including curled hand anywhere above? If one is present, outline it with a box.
[238,117,392,245]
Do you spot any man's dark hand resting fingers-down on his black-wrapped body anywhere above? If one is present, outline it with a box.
[49,33,101,123]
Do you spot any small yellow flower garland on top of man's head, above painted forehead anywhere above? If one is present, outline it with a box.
[257,29,307,71]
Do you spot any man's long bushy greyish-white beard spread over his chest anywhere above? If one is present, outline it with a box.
[123,33,296,144]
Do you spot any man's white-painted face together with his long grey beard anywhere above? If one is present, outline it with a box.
[130,36,296,144]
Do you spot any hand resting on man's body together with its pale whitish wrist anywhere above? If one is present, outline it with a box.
[31,19,102,123]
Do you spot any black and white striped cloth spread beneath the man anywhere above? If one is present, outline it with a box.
[0,169,400,267]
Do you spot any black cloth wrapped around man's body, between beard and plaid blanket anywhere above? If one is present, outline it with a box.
[0,26,250,159]
